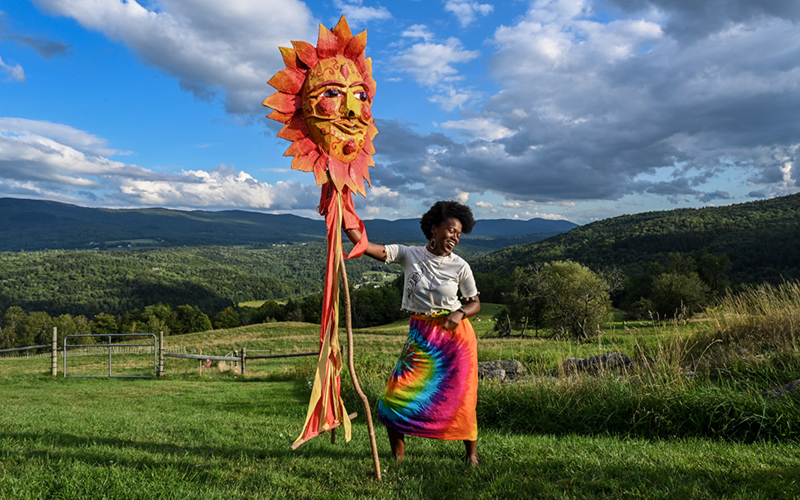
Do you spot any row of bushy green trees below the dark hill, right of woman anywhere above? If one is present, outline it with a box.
[484,249,731,339]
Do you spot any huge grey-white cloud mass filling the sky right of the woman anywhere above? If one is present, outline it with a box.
[376,0,800,209]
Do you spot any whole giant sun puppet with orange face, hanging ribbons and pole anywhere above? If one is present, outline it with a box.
[263,16,380,480]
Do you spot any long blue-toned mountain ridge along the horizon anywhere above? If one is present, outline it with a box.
[0,198,576,253]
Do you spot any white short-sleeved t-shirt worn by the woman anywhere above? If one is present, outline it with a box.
[386,245,478,314]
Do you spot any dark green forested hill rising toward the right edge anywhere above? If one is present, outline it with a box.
[472,194,800,283]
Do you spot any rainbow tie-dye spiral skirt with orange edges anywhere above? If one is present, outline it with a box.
[378,315,478,441]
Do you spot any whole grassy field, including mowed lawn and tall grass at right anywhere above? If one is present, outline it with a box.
[0,290,800,499]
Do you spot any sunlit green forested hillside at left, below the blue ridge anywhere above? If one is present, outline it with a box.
[0,243,382,317]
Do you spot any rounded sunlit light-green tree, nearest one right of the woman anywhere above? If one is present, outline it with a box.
[539,261,621,339]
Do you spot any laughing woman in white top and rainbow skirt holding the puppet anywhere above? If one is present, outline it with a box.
[345,201,481,466]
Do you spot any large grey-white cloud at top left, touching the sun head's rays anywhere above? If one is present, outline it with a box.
[34,0,317,114]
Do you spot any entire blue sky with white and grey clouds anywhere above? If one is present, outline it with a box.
[0,0,800,224]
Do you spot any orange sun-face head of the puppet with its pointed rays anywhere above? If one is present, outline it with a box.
[263,16,378,196]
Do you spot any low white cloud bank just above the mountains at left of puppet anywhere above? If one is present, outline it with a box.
[0,118,319,210]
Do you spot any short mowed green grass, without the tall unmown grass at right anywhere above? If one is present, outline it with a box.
[0,308,800,500]
